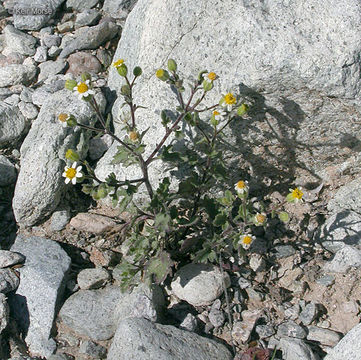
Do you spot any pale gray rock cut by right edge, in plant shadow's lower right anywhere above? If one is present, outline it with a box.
[323,245,361,273]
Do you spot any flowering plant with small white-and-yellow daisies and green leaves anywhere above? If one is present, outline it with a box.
[59,59,303,288]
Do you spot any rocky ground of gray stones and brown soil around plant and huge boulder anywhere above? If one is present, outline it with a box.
[0,0,361,360]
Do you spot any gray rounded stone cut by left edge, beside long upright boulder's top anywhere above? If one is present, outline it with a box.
[0,102,27,148]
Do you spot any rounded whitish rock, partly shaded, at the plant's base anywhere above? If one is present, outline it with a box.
[171,264,230,306]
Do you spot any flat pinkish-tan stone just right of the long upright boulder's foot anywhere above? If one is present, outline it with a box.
[70,213,116,234]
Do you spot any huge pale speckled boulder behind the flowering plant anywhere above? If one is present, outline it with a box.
[97,0,361,197]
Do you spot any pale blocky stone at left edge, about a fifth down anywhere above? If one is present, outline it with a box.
[0,64,36,87]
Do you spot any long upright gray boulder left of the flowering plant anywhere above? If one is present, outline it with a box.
[13,90,104,226]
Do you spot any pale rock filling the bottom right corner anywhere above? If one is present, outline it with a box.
[324,324,361,360]
